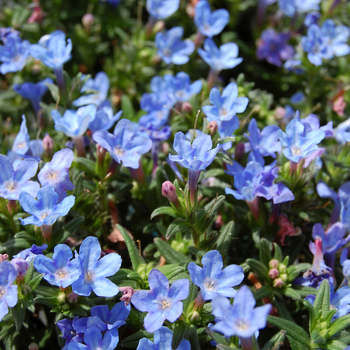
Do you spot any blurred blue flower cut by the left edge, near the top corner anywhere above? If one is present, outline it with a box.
[0,33,30,74]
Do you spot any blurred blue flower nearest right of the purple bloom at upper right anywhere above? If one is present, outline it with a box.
[301,24,333,66]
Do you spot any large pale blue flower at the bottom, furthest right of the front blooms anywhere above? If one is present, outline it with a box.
[211,286,272,338]
